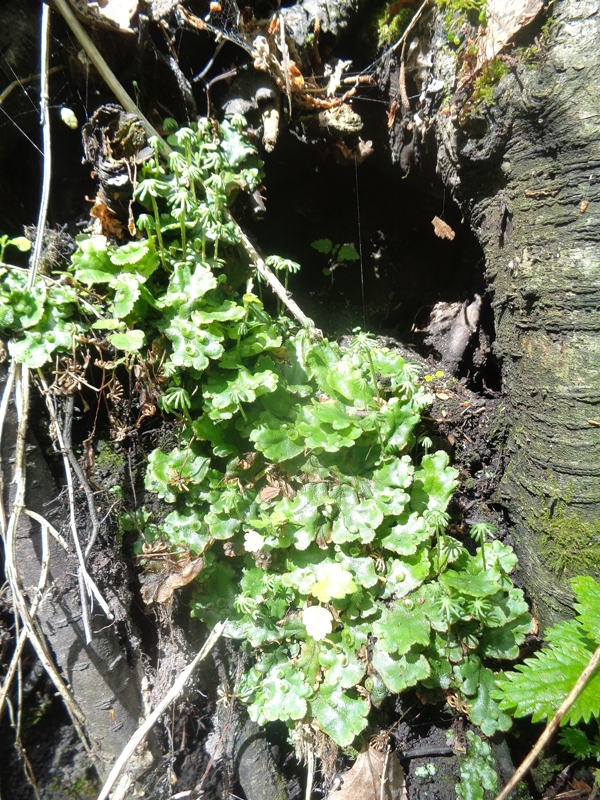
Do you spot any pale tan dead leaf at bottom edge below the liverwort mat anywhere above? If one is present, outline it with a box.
[326,747,408,800]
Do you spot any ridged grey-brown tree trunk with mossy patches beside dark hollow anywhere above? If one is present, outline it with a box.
[437,0,600,622]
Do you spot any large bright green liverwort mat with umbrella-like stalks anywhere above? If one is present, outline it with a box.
[0,117,531,747]
